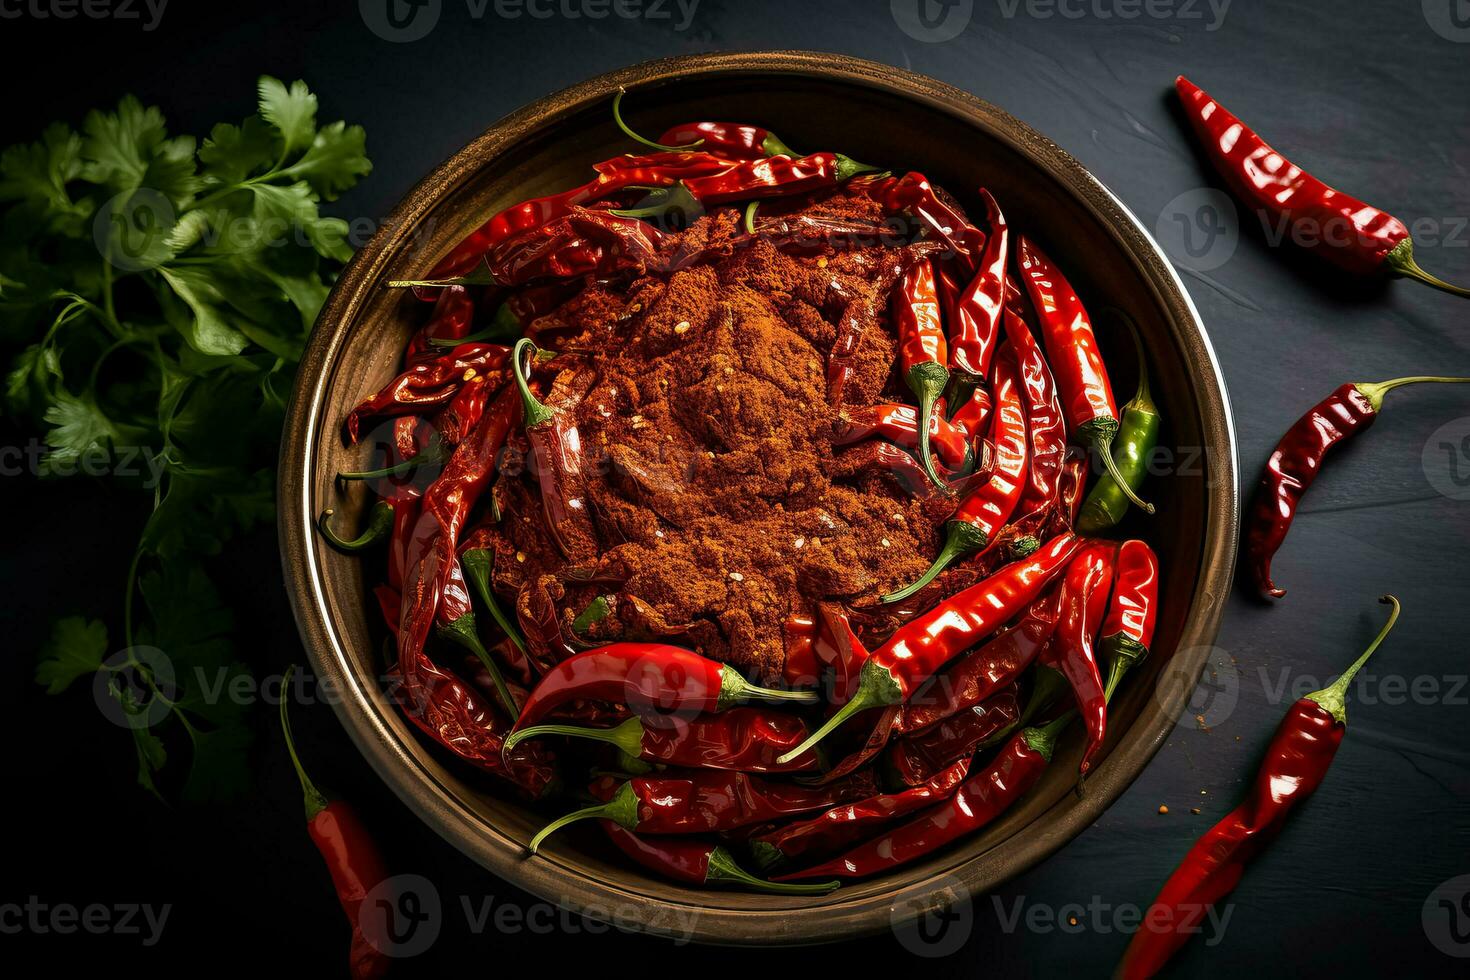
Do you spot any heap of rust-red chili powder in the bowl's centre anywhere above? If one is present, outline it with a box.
[482,195,936,682]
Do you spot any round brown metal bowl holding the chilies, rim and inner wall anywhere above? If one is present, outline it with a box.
[279,51,1238,945]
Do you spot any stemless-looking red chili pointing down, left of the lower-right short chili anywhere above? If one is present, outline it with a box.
[1038,541,1117,786]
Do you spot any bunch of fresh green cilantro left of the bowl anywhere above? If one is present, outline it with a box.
[0,76,372,799]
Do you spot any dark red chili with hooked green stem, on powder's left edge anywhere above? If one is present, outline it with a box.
[510,338,597,564]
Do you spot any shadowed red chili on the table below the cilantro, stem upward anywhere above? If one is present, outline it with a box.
[281,667,390,980]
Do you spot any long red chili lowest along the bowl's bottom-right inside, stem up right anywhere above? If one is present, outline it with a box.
[776,714,1072,882]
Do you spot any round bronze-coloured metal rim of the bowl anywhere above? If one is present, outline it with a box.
[276,51,1239,945]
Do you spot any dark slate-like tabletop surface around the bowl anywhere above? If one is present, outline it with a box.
[0,0,1470,977]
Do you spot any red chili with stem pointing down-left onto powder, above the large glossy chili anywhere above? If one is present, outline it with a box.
[883,345,1029,602]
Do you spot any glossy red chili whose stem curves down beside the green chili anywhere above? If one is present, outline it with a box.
[1016,235,1154,514]
